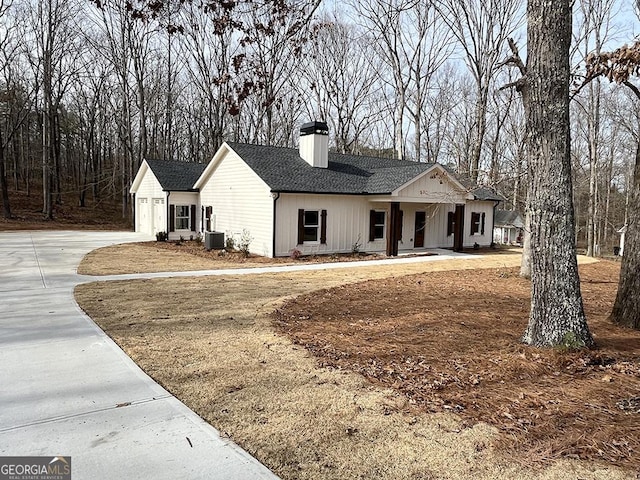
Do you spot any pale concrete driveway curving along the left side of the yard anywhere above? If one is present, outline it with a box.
[0,231,277,480]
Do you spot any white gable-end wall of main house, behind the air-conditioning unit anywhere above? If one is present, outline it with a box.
[200,150,273,257]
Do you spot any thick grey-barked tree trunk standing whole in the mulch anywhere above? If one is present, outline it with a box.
[522,0,593,347]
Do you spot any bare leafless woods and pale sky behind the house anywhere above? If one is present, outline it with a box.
[0,0,640,254]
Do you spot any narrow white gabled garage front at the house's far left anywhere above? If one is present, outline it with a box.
[135,167,167,235]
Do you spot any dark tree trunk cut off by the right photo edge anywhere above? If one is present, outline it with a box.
[610,140,640,329]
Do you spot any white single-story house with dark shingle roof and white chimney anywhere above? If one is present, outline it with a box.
[131,122,502,257]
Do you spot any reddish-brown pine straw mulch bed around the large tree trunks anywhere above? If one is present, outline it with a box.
[274,262,640,471]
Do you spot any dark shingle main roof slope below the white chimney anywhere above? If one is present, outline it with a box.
[227,142,434,194]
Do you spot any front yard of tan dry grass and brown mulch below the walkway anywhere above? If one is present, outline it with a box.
[76,246,640,479]
